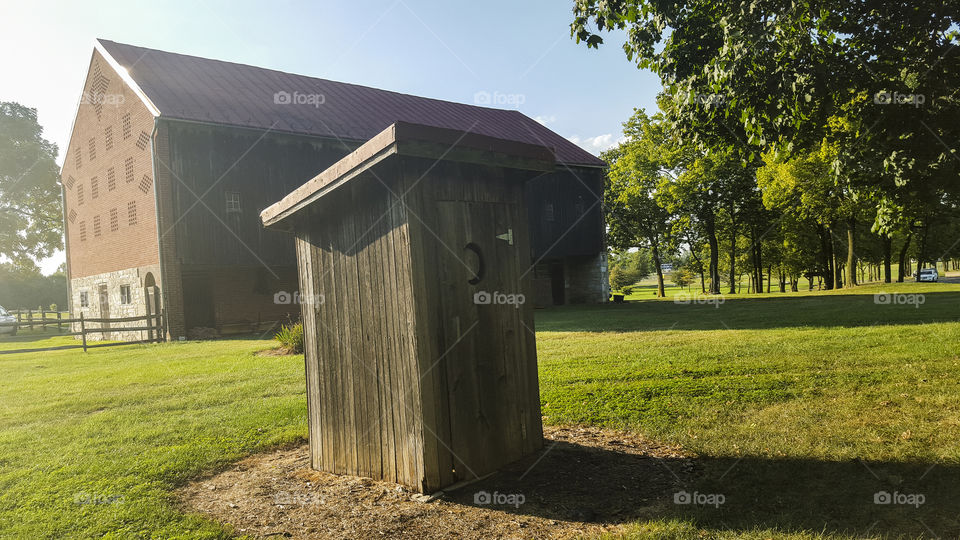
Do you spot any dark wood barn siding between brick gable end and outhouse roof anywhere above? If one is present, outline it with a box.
[165,121,353,266]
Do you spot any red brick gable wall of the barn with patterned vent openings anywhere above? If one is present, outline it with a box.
[61,51,159,278]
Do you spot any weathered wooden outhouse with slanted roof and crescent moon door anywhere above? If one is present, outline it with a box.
[261,123,555,492]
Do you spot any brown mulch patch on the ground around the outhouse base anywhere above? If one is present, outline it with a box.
[179,426,697,540]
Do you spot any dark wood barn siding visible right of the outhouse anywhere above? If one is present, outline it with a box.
[526,164,605,260]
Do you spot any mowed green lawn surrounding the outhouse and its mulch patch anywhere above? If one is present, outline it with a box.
[0,283,960,539]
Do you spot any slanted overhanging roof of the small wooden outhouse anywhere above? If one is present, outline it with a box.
[260,122,556,229]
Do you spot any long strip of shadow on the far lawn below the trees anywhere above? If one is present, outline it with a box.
[536,292,960,332]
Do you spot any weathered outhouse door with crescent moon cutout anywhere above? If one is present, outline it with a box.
[437,201,539,480]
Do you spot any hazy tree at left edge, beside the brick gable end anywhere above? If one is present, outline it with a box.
[0,102,63,267]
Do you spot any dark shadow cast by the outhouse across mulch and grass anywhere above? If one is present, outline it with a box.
[448,441,960,538]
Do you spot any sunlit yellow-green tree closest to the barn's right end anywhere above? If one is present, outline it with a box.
[601,109,675,297]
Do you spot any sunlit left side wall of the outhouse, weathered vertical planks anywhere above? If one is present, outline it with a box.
[296,163,424,487]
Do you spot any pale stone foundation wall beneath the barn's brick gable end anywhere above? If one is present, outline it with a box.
[70,265,161,341]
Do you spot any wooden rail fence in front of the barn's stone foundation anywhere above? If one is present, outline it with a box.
[0,310,167,352]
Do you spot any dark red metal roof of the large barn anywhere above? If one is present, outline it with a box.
[98,39,604,167]
